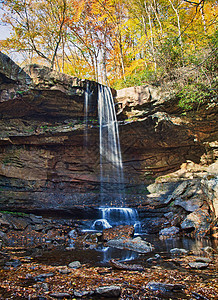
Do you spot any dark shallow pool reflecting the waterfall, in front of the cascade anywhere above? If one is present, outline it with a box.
[34,235,216,266]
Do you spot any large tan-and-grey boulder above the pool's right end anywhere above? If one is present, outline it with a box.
[181,208,211,237]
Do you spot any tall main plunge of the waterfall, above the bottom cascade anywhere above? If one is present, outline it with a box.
[98,85,125,206]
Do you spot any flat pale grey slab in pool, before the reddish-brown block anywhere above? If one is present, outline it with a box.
[107,237,154,253]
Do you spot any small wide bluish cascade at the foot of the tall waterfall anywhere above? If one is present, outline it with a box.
[92,207,141,233]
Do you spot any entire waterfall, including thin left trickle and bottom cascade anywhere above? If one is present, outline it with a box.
[84,83,141,233]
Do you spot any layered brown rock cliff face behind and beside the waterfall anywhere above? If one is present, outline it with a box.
[0,54,218,234]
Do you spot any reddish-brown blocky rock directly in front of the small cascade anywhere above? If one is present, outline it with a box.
[103,225,134,241]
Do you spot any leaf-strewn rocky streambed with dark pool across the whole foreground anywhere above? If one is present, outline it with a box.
[0,212,217,299]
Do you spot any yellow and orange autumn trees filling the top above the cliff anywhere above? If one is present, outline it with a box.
[0,0,218,88]
